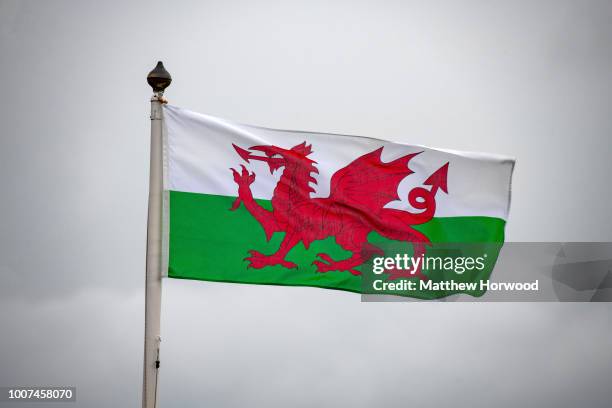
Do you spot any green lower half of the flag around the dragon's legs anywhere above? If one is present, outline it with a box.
[168,191,505,298]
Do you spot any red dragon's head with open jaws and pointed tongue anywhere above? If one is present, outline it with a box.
[232,142,316,173]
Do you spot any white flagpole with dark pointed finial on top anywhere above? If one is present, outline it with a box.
[142,61,172,408]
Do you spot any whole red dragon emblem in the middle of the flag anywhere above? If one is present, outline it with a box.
[230,142,448,279]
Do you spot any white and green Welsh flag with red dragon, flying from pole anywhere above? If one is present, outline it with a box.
[164,106,514,298]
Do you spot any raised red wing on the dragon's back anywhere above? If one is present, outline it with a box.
[329,147,421,212]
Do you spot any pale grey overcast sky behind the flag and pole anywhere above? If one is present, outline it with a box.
[0,0,612,407]
